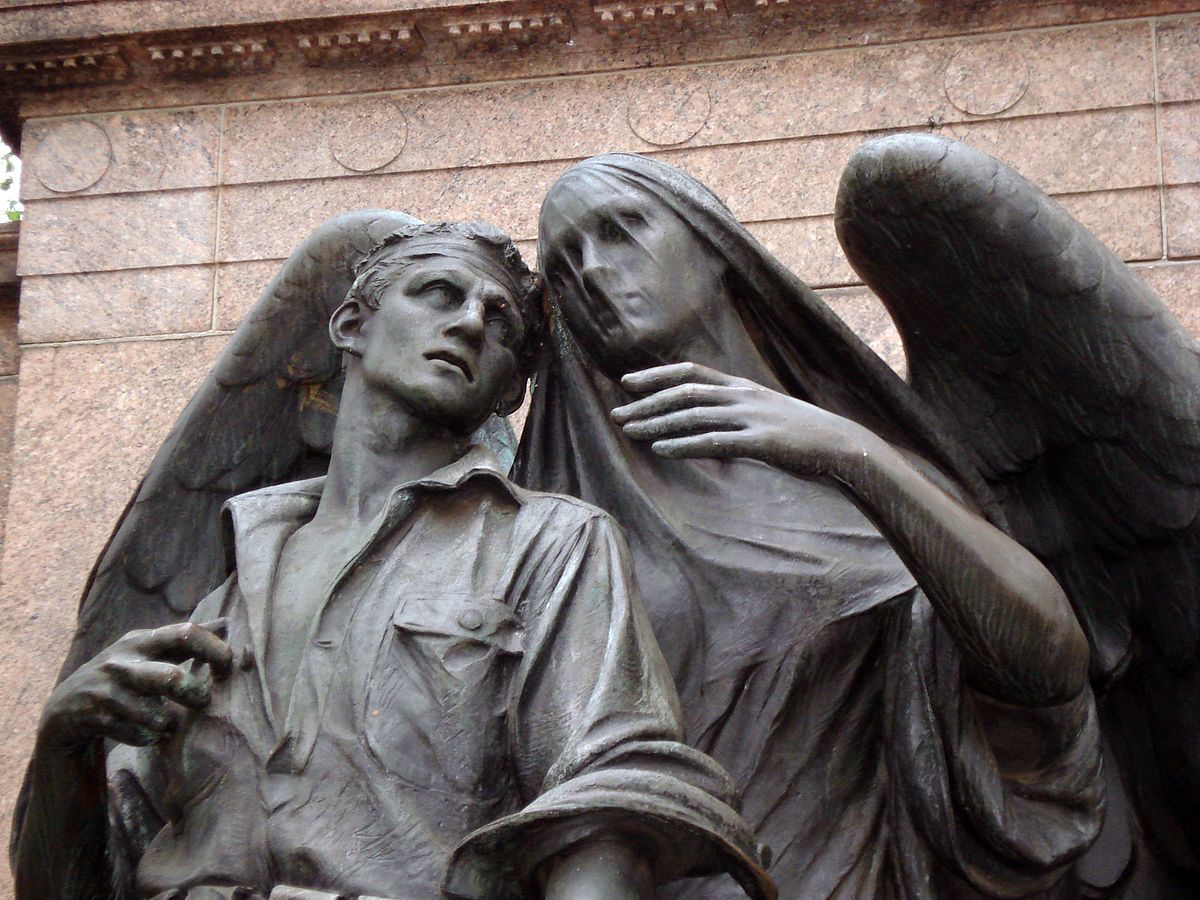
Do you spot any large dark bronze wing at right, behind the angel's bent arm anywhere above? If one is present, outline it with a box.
[836,134,1200,871]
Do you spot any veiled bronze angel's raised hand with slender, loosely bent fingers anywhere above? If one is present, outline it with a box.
[612,362,877,475]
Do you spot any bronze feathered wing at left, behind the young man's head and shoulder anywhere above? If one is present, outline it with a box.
[60,210,516,678]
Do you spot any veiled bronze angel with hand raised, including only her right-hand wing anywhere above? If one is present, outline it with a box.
[517,136,1200,898]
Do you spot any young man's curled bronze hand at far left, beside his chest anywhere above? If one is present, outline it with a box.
[38,619,233,748]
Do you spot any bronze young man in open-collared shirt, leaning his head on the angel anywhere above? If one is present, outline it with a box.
[16,224,772,900]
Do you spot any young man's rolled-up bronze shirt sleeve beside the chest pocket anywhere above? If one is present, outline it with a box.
[445,514,775,898]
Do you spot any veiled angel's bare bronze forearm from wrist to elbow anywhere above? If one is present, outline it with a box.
[834,428,1088,706]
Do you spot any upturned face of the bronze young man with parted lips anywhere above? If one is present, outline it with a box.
[360,245,524,433]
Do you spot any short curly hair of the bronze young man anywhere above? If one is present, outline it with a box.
[347,222,546,378]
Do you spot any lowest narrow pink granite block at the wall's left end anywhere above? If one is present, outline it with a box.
[20,265,214,343]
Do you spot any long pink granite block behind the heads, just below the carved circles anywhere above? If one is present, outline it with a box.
[220,108,1158,262]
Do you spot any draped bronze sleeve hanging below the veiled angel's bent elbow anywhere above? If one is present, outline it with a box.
[886,590,1104,896]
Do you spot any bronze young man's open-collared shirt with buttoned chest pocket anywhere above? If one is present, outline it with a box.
[109,448,764,900]
